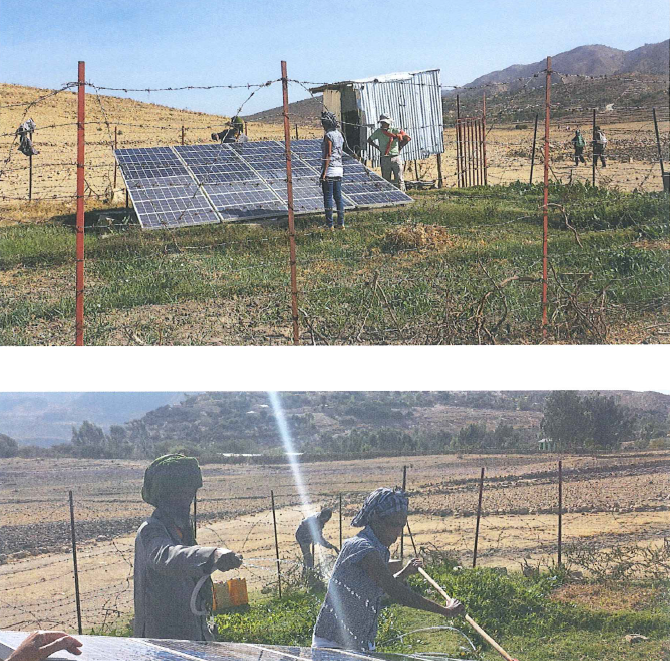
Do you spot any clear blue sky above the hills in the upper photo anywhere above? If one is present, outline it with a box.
[0,0,670,115]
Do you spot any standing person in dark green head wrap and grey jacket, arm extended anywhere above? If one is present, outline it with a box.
[133,454,242,640]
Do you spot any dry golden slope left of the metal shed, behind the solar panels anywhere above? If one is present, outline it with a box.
[0,83,321,226]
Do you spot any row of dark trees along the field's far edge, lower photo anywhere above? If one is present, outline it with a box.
[0,390,670,462]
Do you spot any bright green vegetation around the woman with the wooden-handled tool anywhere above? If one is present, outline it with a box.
[211,563,670,661]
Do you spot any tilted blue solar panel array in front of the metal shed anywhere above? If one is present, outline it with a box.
[115,140,412,229]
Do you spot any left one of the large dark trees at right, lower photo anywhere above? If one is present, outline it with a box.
[540,390,588,450]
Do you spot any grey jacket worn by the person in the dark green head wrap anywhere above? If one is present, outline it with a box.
[133,508,217,640]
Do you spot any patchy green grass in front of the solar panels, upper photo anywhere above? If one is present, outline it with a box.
[0,183,670,344]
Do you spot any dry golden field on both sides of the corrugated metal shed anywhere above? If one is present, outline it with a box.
[0,84,670,226]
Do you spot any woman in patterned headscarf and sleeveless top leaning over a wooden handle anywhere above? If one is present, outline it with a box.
[312,487,464,652]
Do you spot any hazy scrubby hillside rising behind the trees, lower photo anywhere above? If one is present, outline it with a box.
[118,391,670,452]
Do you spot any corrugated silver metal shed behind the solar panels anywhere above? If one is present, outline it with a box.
[311,69,444,166]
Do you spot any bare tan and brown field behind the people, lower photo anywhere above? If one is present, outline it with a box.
[0,452,670,629]
